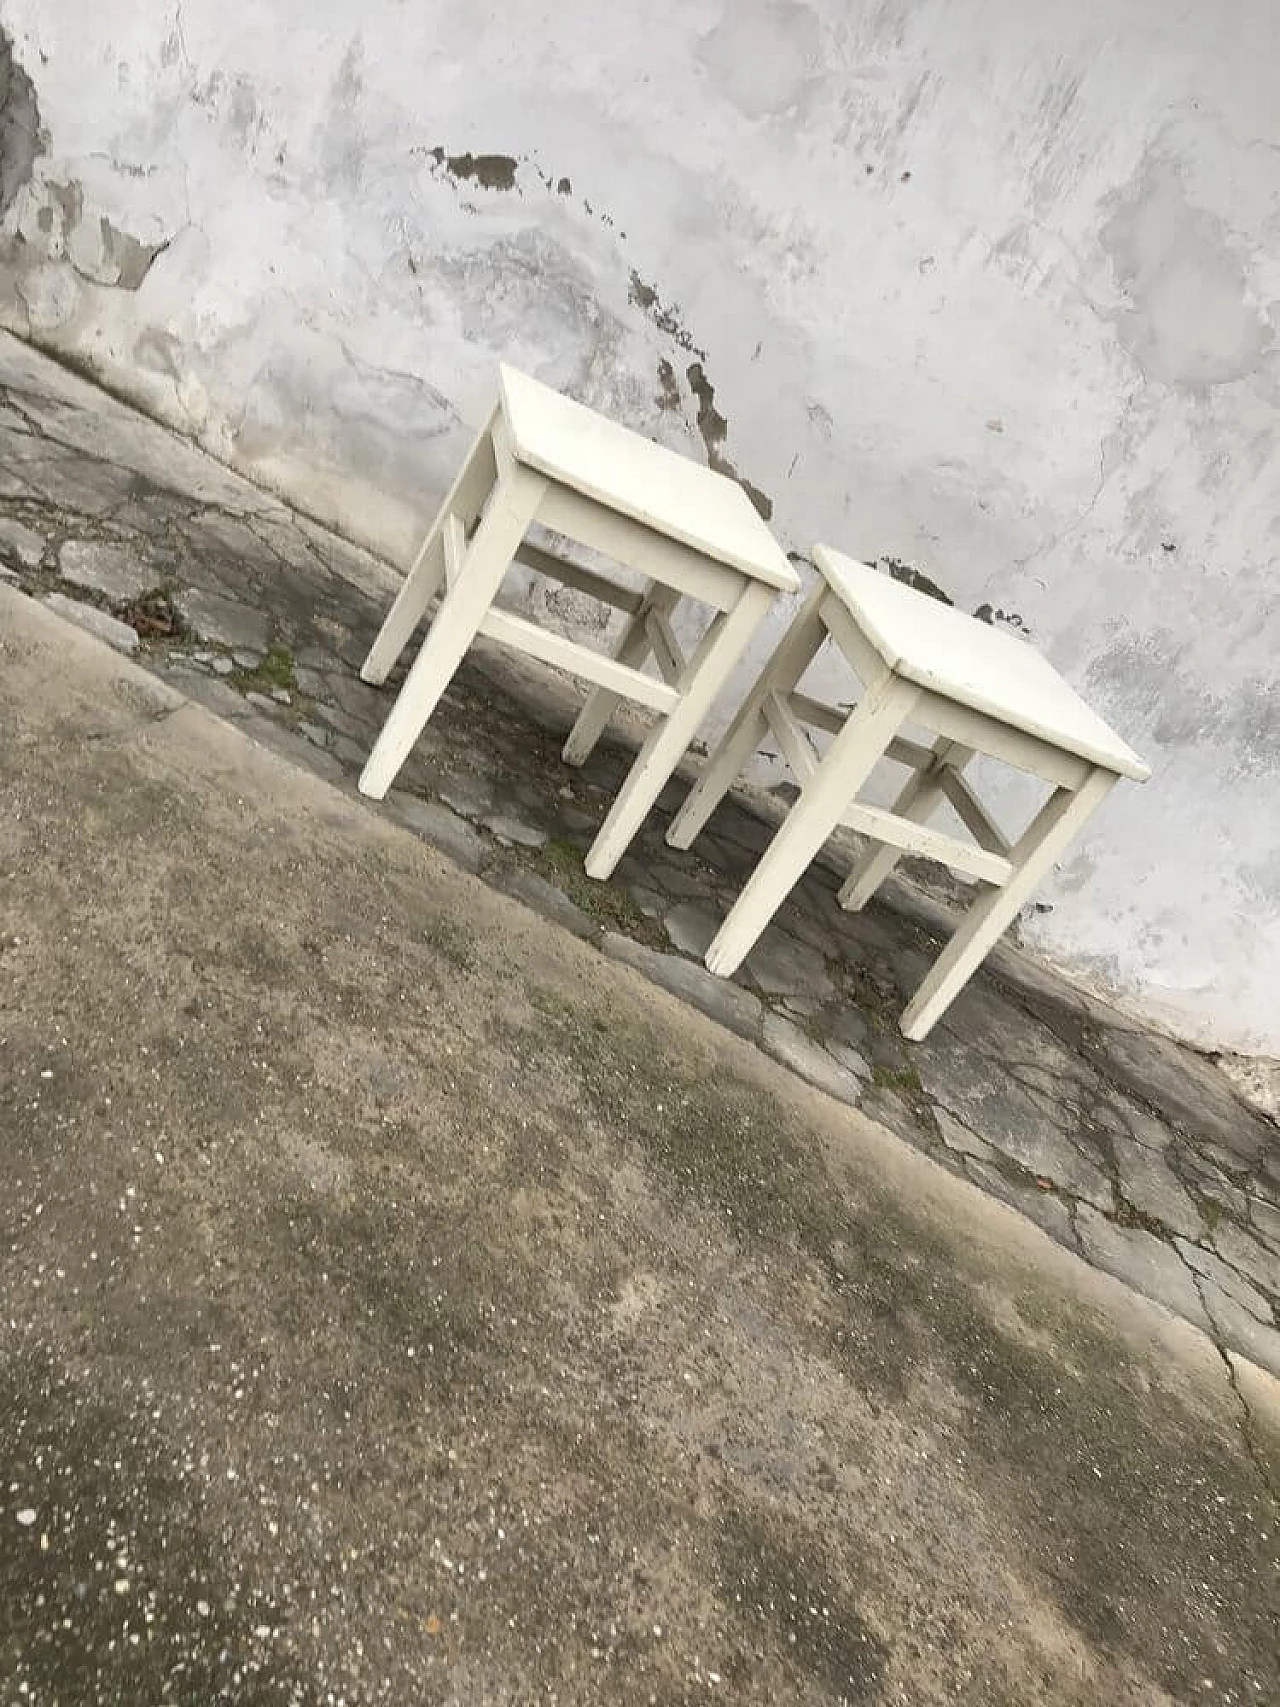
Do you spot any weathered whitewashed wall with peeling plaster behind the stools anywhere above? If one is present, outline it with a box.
[0,0,1280,1053]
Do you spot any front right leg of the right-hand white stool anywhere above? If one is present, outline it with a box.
[899,768,1116,1043]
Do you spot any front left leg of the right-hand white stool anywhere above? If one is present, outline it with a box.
[707,676,920,978]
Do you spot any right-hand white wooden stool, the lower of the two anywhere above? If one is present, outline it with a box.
[667,545,1150,1041]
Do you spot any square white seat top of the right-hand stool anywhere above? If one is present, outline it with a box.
[814,545,1150,782]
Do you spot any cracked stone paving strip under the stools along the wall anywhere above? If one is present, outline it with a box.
[0,338,1280,1374]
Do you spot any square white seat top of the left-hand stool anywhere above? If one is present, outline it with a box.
[498,365,800,592]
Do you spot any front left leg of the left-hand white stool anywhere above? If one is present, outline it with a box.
[358,464,546,801]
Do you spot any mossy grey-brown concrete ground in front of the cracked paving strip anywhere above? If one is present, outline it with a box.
[0,587,1280,1707]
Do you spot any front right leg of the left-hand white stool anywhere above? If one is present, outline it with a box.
[585,580,773,877]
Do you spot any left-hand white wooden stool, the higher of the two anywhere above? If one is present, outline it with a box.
[360,367,800,877]
